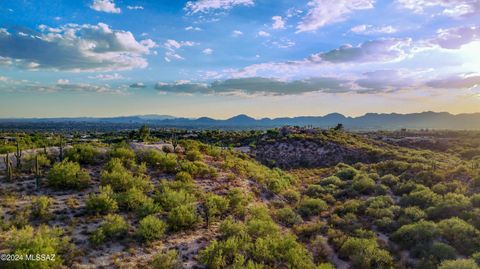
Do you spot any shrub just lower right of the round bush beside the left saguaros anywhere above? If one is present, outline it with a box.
[86,185,118,214]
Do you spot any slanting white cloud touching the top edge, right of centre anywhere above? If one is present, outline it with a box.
[297,0,375,33]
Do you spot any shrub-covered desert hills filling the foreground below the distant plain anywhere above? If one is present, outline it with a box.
[0,127,480,269]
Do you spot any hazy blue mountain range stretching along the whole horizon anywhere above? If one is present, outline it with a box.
[0,112,480,130]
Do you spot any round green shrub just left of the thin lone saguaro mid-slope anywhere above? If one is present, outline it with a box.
[167,205,198,231]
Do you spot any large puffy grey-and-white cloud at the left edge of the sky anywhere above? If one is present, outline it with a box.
[0,23,157,71]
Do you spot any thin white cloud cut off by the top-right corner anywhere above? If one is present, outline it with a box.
[396,0,480,17]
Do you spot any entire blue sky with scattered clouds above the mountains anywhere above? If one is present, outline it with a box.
[0,0,480,118]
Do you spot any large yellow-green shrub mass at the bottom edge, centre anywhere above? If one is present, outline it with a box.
[199,211,315,269]
